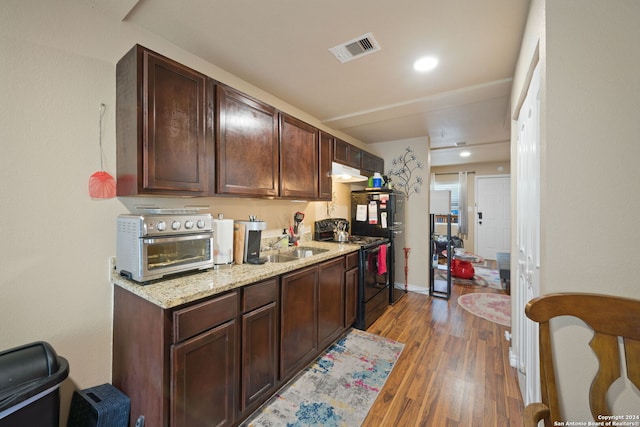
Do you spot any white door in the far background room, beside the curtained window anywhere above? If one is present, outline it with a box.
[475,175,511,259]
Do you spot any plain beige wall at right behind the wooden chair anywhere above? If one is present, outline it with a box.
[512,0,640,421]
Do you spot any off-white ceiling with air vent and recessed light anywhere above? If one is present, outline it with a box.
[94,0,530,166]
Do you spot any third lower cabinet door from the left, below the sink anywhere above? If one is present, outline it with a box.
[280,267,318,380]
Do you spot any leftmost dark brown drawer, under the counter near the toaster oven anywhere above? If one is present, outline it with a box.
[173,291,238,342]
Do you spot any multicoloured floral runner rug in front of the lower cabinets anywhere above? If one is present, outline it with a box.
[242,329,404,427]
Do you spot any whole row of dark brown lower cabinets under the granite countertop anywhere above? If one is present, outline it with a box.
[112,254,358,427]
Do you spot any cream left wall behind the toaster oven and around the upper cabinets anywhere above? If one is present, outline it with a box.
[0,0,362,423]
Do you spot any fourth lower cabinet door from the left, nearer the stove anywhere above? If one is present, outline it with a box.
[318,257,344,348]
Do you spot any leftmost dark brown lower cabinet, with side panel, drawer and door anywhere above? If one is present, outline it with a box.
[112,286,239,427]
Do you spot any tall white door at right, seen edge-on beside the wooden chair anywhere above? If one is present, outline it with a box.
[511,61,540,405]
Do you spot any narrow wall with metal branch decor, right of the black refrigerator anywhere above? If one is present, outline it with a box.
[368,137,430,293]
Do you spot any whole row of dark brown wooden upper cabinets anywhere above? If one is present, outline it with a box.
[116,45,384,200]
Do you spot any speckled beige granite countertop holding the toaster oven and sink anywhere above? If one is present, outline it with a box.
[111,241,360,309]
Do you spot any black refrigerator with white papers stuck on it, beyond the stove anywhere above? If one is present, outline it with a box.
[351,190,406,304]
